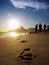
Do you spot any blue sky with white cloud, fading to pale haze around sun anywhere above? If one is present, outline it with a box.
[0,0,49,31]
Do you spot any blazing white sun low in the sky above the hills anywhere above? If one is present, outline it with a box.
[8,18,20,30]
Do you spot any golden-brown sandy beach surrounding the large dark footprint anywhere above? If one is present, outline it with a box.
[0,33,49,65]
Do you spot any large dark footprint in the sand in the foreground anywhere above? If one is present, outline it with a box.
[18,48,36,63]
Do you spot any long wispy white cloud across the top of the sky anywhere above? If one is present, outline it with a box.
[10,0,49,10]
